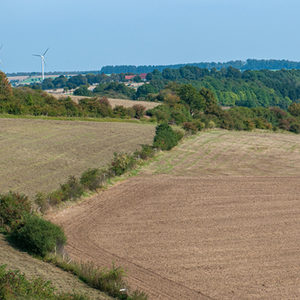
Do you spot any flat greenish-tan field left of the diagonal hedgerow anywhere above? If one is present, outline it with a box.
[0,118,155,196]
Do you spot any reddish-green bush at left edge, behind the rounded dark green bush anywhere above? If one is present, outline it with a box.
[0,192,31,229]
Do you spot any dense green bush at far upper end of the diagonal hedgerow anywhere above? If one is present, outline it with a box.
[153,123,178,150]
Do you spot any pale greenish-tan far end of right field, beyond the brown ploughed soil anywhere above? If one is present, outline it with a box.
[145,130,300,176]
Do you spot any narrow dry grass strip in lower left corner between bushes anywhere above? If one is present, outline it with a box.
[0,234,112,300]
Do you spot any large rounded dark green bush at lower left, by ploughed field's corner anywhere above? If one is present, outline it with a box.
[10,215,66,257]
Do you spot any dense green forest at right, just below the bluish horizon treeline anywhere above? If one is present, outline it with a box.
[137,66,300,109]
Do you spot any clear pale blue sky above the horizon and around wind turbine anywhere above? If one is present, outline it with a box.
[0,0,300,72]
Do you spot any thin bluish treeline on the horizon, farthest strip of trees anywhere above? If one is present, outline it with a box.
[100,59,300,74]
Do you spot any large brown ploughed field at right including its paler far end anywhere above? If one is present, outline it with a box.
[48,130,300,299]
